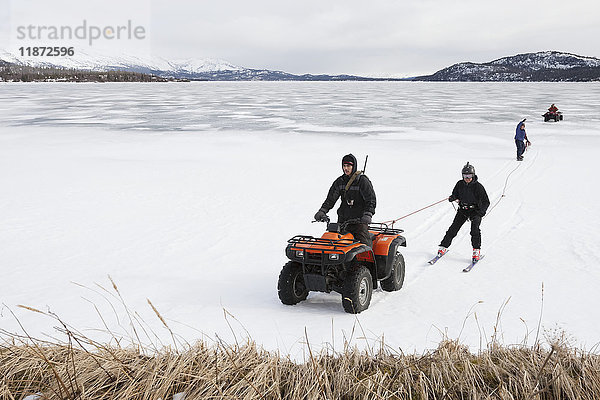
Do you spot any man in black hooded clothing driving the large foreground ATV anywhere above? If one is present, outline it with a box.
[315,154,376,247]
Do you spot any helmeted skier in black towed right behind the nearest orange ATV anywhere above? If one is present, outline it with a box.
[438,162,490,262]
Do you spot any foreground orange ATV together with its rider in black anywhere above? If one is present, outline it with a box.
[277,154,406,314]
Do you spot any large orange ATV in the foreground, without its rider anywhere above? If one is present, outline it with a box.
[277,219,406,314]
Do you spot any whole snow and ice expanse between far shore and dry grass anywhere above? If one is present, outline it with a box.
[0,82,600,356]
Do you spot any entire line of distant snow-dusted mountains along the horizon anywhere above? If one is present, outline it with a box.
[0,50,600,82]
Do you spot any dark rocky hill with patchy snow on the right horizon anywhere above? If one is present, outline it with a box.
[414,51,600,81]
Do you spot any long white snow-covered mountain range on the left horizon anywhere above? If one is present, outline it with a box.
[0,50,376,81]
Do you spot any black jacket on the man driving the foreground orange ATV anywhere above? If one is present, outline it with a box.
[321,152,377,223]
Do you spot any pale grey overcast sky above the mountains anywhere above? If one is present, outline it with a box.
[0,0,600,76]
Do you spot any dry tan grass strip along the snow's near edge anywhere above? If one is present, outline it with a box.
[0,282,600,400]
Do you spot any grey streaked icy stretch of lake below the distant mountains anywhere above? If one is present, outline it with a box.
[0,82,600,135]
